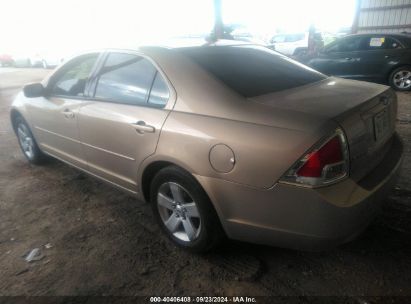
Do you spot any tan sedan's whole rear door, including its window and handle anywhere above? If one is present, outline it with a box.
[79,52,175,192]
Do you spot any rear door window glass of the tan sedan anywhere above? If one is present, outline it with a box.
[94,53,168,106]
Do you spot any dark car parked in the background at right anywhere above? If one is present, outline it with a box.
[300,34,411,91]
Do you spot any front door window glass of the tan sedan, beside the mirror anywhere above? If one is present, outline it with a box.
[51,54,98,97]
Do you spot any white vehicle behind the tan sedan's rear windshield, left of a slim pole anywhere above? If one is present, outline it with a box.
[270,32,308,56]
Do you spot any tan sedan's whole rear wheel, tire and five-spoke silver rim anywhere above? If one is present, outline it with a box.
[150,166,224,253]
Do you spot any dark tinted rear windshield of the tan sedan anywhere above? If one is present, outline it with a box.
[180,45,326,97]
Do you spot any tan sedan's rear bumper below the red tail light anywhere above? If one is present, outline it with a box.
[197,135,403,251]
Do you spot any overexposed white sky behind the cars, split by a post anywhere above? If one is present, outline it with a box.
[0,0,355,54]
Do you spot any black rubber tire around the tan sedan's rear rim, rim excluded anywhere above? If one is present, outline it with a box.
[150,166,222,253]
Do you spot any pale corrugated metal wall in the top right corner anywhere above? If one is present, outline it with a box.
[353,0,411,33]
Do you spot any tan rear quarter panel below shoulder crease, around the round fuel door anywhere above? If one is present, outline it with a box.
[154,111,336,188]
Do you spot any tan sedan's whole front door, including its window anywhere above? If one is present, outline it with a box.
[29,53,99,168]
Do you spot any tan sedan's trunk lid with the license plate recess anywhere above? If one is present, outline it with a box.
[251,77,397,181]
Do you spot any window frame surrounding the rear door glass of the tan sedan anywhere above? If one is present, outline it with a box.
[88,49,177,110]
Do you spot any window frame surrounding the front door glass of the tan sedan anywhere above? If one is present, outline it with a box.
[46,51,102,100]
